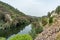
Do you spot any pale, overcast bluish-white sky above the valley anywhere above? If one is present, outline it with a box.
[0,0,60,17]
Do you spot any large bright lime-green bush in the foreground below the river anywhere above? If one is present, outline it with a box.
[9,34,32,40]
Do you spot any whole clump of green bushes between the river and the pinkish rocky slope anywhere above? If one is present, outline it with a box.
[30,22,43,40]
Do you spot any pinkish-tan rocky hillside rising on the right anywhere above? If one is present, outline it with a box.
[35,6,60,40]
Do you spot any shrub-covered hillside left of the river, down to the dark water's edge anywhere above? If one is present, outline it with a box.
[0,1,38,37]
